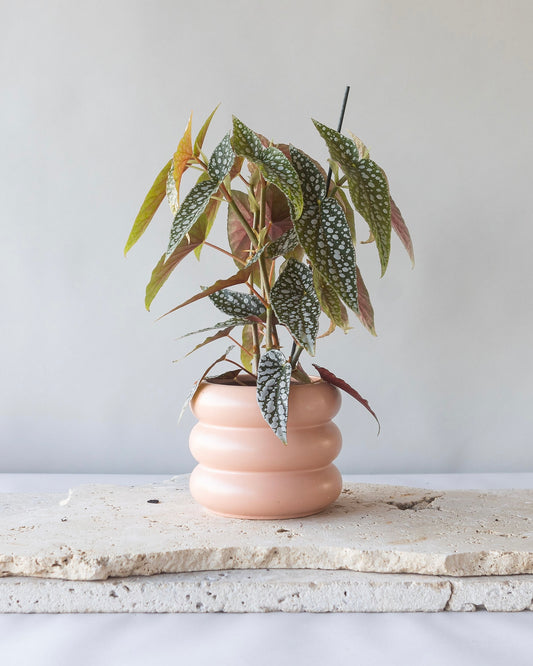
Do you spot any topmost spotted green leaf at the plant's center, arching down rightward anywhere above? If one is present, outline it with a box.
[232,116,303,219]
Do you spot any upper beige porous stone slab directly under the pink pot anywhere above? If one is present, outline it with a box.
[0,476,533,580]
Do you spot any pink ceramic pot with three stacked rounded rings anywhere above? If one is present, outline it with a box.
[189,380,342,519]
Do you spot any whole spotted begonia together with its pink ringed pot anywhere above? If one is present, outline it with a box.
[125,98,413,518]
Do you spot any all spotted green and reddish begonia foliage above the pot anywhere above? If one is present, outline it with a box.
[125,107,414,443]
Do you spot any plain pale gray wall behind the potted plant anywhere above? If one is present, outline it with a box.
[0,0,533,473]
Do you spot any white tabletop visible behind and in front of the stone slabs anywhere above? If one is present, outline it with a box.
[0,474,533,666]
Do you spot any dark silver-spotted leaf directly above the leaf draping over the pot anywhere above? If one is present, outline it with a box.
[270,259,320,356]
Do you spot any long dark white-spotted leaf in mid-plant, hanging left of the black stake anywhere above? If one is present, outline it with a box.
[291,146,358,313]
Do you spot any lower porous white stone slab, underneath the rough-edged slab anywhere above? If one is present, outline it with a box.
[0,569,533,613]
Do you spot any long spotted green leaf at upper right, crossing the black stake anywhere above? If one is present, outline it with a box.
[313,120,391,275]
